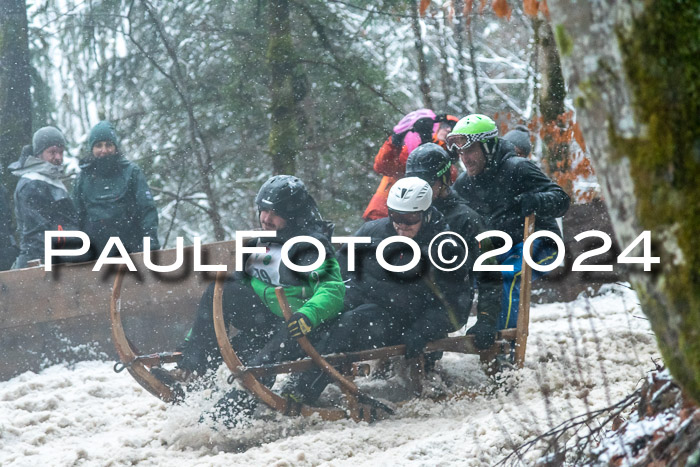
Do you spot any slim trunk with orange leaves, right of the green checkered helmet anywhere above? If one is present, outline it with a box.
[534,19,573,186]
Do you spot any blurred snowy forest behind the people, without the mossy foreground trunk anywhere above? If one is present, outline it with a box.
[0,0,594,247]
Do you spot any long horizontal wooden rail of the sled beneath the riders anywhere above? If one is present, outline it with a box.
[244,328,516,377]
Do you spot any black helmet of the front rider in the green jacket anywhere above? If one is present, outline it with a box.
[255,175,320,222]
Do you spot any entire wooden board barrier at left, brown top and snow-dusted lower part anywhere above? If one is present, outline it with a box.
[0,242,235,381]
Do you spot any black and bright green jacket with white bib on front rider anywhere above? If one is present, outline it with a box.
[236,221,345,327]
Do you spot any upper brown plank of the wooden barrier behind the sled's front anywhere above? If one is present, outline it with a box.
[0,241,235,330]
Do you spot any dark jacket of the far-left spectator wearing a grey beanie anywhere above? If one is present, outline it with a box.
[10,156,78,268]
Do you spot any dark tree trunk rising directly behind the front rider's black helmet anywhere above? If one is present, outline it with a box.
[267,0,298,174]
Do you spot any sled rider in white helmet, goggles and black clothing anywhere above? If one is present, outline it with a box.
[283,177,473,404]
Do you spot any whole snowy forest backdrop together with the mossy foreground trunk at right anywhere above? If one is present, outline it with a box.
[0,0,700,424]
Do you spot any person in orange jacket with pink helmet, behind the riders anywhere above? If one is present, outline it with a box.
[362,109,458,221]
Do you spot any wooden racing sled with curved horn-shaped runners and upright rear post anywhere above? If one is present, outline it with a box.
[110,216,534,421]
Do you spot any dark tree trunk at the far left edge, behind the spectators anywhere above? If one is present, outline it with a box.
[0,0,32,193]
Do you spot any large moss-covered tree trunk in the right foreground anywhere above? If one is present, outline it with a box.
[548,0,700,402]
